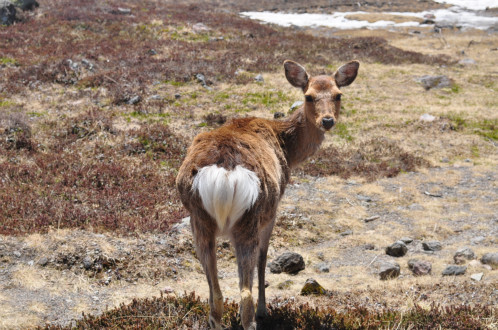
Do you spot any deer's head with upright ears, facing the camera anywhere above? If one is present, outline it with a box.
[284,60,360,132]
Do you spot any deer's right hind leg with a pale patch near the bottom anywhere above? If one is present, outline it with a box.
[232,228,258,330]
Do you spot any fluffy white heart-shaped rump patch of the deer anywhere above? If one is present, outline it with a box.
[192,165,260,233]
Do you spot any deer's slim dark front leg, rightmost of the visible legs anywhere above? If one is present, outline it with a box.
[256,218,275,320]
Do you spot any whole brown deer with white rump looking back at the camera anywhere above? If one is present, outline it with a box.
[176,61,359,329]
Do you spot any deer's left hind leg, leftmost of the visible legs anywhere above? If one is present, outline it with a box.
[191,215,223,329]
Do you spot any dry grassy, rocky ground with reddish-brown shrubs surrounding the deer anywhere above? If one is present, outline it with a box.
[0,0,498,329]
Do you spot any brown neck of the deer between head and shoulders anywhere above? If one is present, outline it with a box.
[277,107,324,168]
